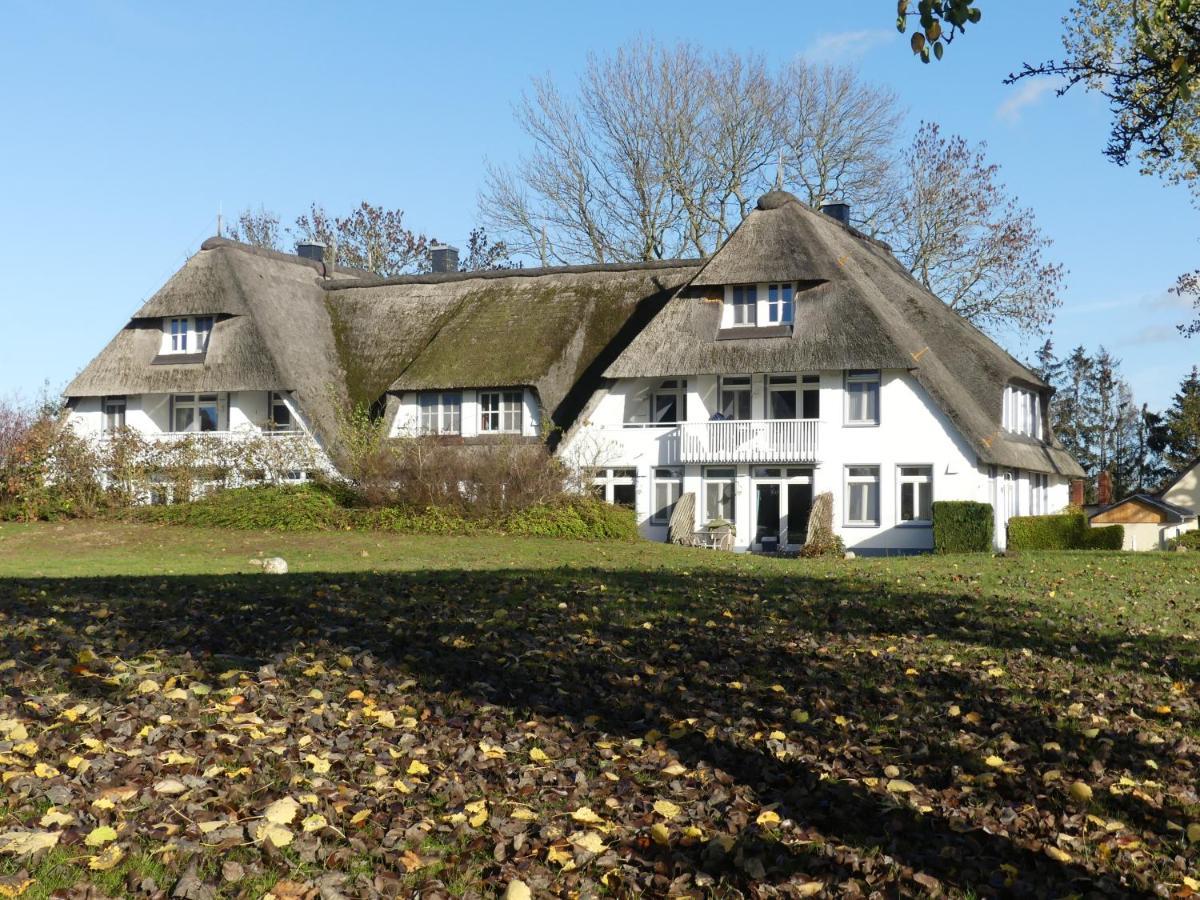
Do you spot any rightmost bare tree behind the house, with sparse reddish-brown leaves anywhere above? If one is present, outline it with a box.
[890,122,1064,332]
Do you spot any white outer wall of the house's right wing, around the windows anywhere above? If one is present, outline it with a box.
[560,370,1068,552]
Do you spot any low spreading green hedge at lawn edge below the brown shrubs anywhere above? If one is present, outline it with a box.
[127,484,637,540]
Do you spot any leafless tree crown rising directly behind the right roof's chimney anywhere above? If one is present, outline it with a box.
[776,60,904,234]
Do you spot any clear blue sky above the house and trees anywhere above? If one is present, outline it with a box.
[0,0,1200,406]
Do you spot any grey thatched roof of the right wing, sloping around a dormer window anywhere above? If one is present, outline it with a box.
[605,191,1082,476]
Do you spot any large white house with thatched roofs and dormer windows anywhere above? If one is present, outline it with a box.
[67,191,1081,552]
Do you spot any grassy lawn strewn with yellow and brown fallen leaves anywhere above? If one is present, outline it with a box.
[0,523,1200,899]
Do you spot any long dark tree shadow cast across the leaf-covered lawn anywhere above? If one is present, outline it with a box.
[0,569,1195,895]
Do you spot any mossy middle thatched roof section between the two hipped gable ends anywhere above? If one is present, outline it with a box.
[326,262,698,426]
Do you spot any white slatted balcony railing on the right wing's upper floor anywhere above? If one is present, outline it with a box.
[679,419,817,463]
